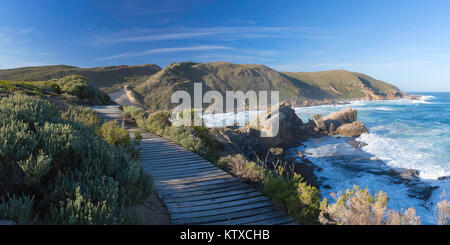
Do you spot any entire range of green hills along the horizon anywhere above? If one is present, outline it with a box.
[0,62,408,110]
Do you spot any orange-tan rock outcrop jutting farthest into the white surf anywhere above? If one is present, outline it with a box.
[313,108,369,137]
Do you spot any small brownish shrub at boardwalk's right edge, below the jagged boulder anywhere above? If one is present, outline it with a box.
[218,154,265,185]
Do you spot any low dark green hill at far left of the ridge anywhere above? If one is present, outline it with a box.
[0,64,161,93]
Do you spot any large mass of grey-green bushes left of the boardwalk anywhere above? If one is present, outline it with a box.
[0,95,152,224]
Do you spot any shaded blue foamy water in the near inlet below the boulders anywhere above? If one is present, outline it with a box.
[299,137,435,224]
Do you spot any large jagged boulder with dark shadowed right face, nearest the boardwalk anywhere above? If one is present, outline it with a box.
[241,102,306,154]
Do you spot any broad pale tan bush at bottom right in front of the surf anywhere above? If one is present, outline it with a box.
[320,186,420,225]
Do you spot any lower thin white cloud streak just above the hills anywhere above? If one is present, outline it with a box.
[98,45,232,60]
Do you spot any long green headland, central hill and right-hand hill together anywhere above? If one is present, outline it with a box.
[134,62,406,110]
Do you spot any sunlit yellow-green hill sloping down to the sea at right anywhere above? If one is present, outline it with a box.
[284,70,405,99]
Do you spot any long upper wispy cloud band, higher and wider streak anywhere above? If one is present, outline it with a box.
[96,26,324,44]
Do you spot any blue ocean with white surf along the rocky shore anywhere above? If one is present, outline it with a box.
[204,93,450,224]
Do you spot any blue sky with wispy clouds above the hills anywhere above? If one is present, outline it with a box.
[0,0,450,91]
